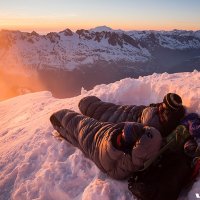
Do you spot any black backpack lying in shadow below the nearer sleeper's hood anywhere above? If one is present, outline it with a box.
[128,149,192,200]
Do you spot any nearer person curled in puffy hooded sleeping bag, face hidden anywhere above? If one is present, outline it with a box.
[50,109,162,179]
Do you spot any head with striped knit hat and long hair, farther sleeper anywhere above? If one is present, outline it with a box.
[158,93,185,123]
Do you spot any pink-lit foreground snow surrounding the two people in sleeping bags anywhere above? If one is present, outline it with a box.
[0,70,200,200]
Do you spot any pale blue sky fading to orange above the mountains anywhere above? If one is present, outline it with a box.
[0,0,200,33]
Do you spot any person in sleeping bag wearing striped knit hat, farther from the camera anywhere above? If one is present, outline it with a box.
[78,93,185,137]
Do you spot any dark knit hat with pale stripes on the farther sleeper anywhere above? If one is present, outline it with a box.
[163,93,182,110]
